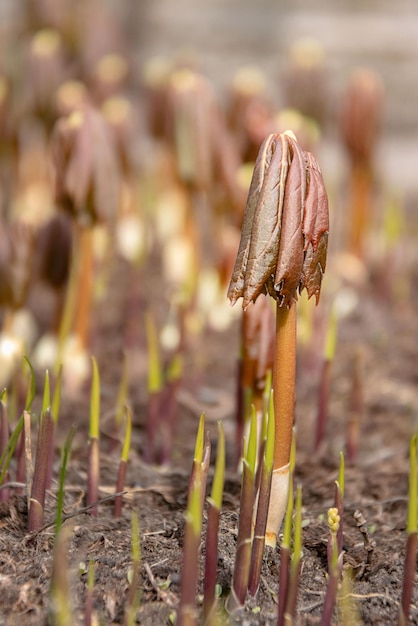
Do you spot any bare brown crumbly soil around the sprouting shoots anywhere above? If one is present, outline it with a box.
[0,1,418,626]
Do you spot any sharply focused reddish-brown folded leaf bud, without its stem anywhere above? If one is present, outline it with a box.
[228,132,329,309]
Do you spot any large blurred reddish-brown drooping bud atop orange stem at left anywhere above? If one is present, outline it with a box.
[52,105,119,223]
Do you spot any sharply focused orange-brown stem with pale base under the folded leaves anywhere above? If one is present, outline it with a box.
[266,302,296,547]
